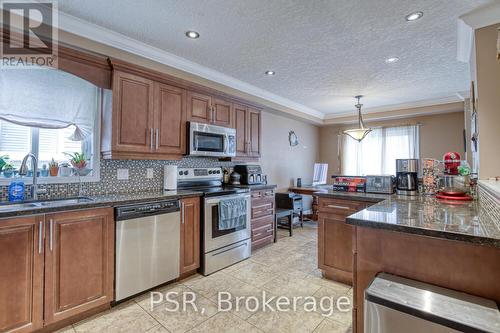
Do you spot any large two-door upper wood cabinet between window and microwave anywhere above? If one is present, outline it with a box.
[101,70,186,159]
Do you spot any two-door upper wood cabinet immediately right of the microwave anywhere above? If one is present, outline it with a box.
[234,104,261,159]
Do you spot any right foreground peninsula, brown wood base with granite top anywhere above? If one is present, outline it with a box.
[344,195,500,332]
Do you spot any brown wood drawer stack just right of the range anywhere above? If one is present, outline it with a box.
[251,189,276,251]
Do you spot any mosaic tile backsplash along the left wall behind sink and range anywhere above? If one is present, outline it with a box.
[0,157,235,201]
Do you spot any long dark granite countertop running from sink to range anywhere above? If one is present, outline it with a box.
[0,190,203,219]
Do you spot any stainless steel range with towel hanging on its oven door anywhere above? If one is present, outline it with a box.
[177,168,251,275]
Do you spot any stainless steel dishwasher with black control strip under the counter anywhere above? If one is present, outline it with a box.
[115,200,180,301]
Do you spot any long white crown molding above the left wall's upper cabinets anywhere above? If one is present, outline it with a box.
[59,11,324,120]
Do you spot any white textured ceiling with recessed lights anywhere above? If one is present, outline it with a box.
[59,0,491,114]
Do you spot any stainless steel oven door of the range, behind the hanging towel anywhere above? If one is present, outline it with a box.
[204,193,251,253]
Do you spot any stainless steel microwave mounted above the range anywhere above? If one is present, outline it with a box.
[187,122,236,157]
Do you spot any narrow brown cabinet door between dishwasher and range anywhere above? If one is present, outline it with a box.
[180,197,200,275]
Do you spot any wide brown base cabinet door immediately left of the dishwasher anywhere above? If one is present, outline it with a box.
[45,208,115,324]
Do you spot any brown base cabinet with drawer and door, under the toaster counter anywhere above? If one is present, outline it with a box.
[318,197,367,285]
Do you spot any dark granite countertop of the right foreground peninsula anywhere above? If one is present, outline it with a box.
[346,195,500,248]
